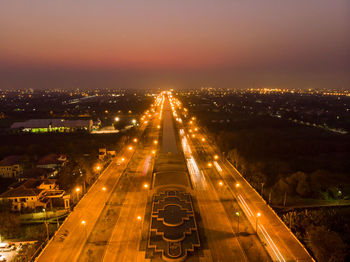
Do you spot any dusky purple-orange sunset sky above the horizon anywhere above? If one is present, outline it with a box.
[0,0,350,89]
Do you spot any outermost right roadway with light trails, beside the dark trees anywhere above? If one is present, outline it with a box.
[172,94,314,261]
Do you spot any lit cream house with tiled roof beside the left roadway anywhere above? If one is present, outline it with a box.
[0,179,69,211]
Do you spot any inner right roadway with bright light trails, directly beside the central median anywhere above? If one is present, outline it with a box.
[174,98,270,261]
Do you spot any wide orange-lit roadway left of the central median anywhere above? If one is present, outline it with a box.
[36,99,160,262]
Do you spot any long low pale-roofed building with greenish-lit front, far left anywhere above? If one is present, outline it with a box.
[11,119,93,133]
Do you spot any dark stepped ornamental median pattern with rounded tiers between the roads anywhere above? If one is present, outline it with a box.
[148,190,200,261]
